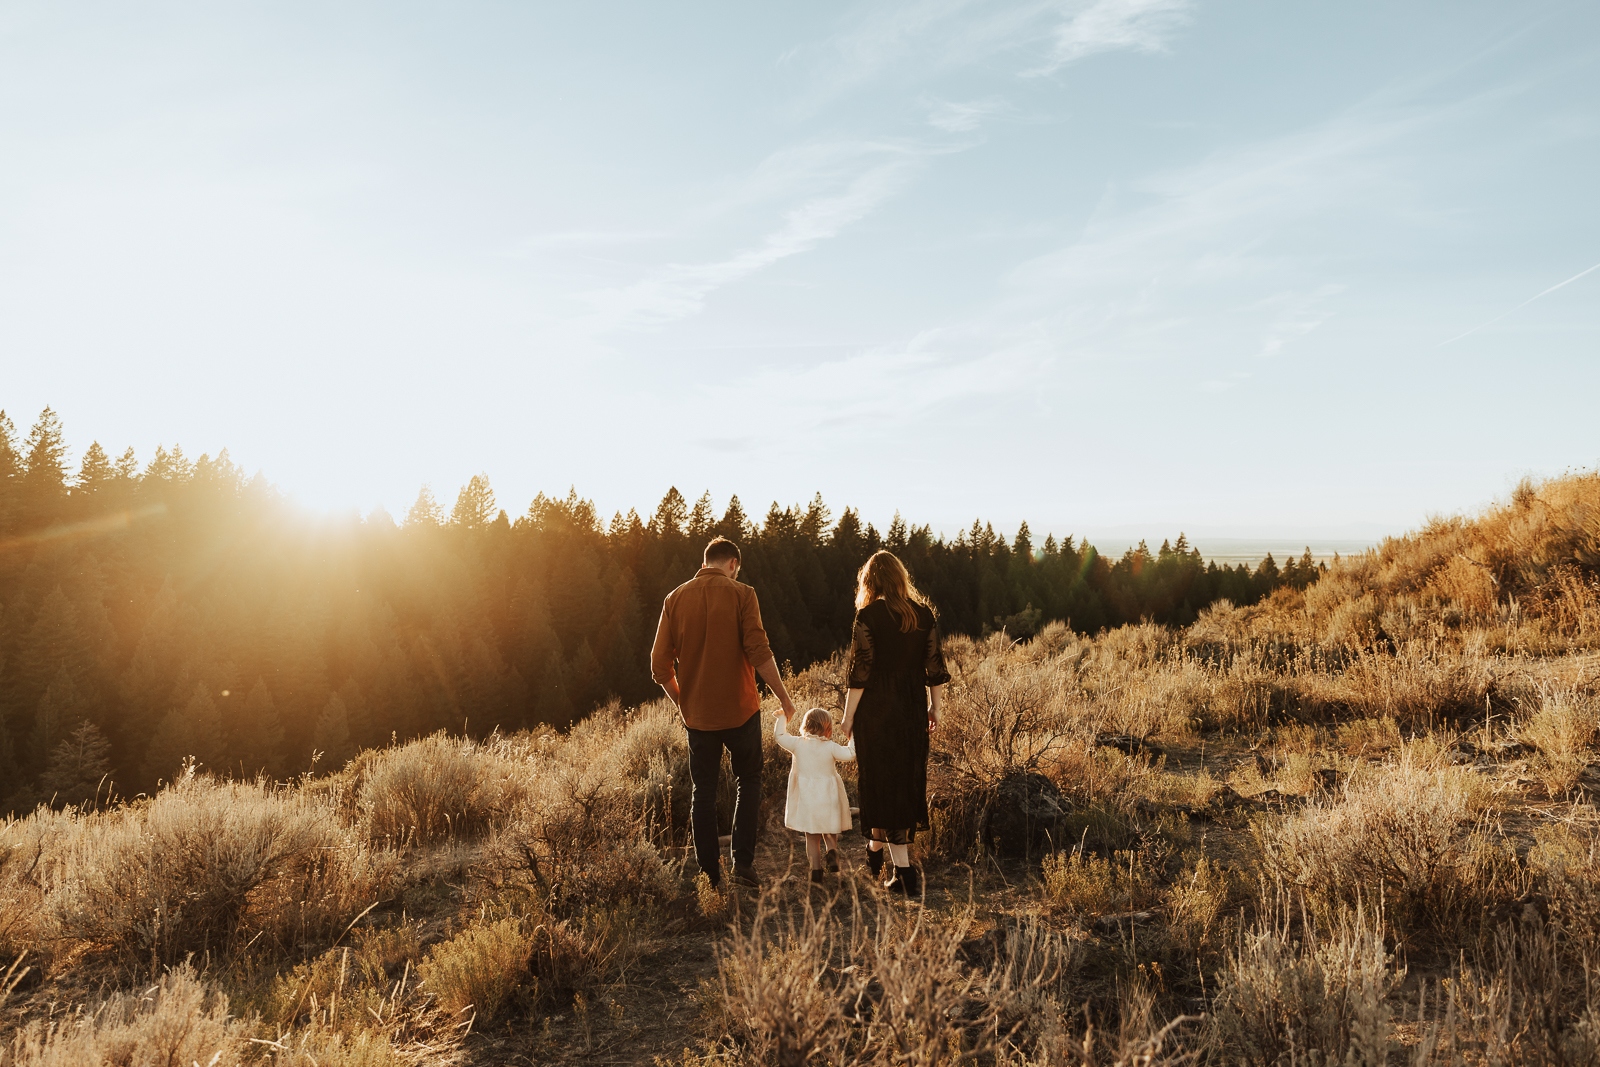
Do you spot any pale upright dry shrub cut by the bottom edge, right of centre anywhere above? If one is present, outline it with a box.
[1208,902,1405,1067]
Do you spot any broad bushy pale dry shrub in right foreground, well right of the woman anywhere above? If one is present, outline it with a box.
[1253,760,1515,936]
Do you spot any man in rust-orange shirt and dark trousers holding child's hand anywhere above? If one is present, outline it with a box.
[650,537,795,888]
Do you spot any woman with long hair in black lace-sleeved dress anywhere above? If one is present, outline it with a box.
[845,552,950,896]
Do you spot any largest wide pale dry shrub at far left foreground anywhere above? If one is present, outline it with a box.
[40,774,395,963]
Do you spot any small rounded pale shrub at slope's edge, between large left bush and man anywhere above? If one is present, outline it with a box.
[357,733,522,845]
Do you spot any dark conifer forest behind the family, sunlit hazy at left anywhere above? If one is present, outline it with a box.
[0,408,1318,809]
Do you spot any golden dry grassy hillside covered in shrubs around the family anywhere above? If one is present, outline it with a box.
[0,474,1600,1067]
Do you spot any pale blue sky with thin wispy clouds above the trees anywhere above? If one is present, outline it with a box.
[0,0,1600,537]
